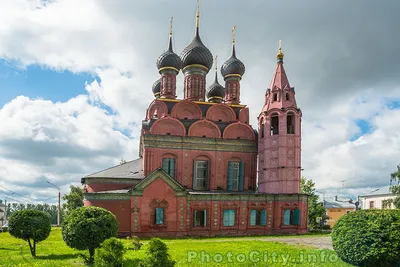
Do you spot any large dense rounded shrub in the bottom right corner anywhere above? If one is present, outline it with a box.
[332,210,400,267]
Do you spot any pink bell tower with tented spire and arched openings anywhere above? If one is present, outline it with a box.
[258,41,302,194]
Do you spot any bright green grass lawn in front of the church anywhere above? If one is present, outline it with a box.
[0,228,350,267]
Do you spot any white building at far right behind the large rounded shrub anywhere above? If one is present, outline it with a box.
[360,186,396,210]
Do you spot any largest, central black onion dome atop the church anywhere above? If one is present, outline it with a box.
[181,28,213,69]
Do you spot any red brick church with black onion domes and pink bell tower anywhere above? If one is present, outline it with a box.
[82,7,308,237]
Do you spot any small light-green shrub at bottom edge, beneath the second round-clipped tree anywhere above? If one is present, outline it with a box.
[94,237,126,267]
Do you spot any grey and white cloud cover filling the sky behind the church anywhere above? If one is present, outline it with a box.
[0,0,400,203]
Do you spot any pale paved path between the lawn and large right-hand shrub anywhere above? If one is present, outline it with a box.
[259,236,333,249]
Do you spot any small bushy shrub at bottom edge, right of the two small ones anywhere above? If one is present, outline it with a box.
[143,238,175,267]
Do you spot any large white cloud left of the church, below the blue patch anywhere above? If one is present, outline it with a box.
[0,95,137,202]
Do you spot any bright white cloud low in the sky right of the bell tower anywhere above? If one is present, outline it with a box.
[302,90,400,199]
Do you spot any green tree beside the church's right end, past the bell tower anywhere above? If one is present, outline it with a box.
[300,177,326,228]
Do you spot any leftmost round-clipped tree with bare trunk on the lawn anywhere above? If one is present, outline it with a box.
[8,210,51,257]
